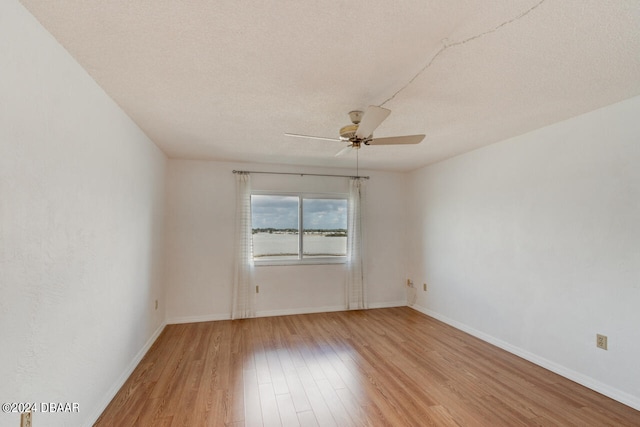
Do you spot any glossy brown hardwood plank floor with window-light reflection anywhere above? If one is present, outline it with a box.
[96,307,640,427]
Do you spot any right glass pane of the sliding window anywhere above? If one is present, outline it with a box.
[302,199,347,257]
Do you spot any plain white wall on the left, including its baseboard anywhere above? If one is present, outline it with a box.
[0,1,165,426]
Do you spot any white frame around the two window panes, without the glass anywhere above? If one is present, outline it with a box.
[251,190,349,267]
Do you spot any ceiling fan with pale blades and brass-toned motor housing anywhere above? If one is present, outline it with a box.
[285,105,424,157]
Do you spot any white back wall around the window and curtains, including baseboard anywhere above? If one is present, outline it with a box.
[166,160,406,323]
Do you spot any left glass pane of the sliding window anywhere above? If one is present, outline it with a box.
[251,195,299,260]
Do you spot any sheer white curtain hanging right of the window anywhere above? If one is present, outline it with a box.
[347,178,368,310]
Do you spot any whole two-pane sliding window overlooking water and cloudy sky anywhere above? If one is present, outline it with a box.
[251,194,347,264]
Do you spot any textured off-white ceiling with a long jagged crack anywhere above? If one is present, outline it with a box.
[22,0,640,171]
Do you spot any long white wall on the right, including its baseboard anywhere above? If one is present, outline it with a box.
[409,98,640,409]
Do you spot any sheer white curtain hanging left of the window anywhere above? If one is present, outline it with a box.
[231,172,255,319]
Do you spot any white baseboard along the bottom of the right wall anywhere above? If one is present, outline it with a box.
[409,304,640,410]
